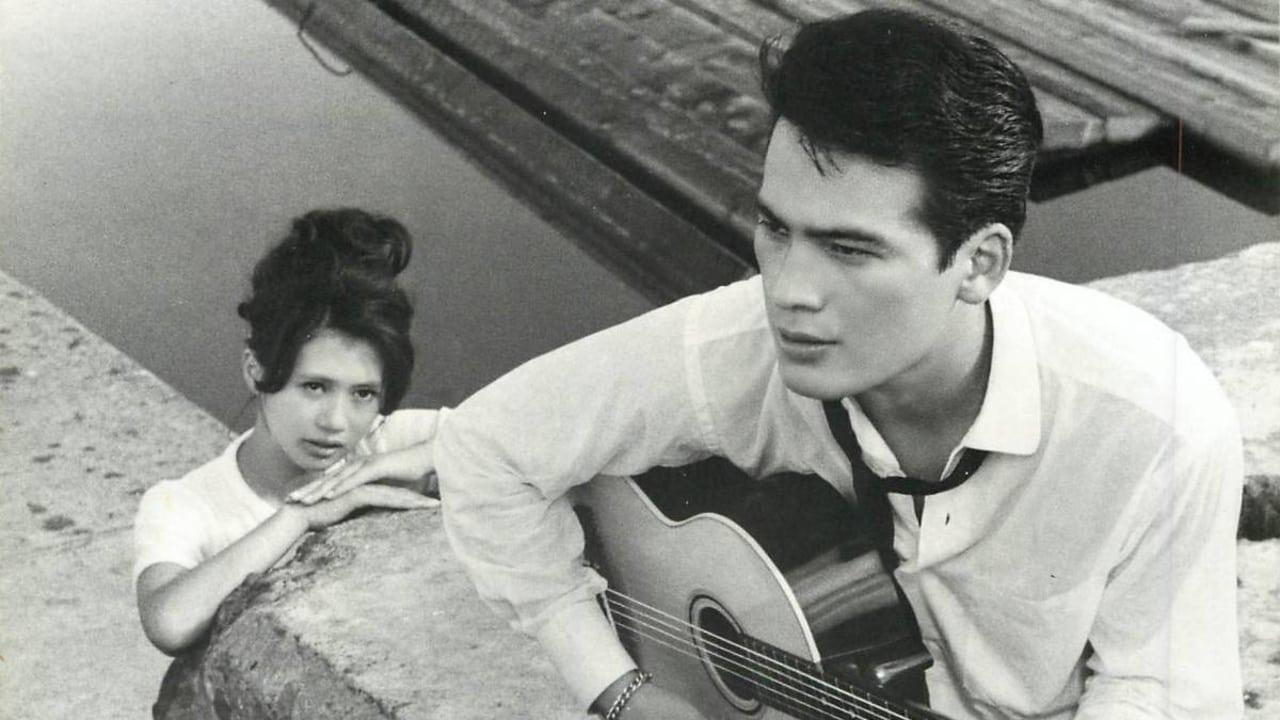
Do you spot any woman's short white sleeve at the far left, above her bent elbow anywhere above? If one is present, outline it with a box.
[133,480,205,584]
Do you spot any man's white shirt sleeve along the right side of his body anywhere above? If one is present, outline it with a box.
[1076,376,1244,720]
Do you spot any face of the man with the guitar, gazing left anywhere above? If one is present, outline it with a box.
[755,120,963,400]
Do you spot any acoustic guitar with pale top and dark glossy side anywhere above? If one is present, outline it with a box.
[573,459,945,720]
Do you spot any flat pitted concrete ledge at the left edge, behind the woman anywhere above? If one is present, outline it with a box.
[0,272,229,720]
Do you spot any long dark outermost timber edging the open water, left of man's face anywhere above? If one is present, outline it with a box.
[269,0,750,302]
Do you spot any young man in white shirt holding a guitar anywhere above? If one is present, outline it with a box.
[435,12,1242,720]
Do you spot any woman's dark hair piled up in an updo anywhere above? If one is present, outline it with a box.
[237,209,413,414]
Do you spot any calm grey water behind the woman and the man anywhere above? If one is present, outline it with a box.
[0,0,1280,423]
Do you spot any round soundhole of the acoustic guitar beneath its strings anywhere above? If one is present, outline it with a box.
[689,596,762,712]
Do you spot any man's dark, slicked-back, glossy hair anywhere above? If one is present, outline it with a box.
[760,10,1043,269]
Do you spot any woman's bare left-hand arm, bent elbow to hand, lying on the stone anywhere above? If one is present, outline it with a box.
[137,486,435,655]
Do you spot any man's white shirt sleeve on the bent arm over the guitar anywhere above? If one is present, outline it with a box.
[435,292,714,706]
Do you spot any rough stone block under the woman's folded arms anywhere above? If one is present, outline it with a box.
[148,510,582,720]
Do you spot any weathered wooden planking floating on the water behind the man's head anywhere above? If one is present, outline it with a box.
[268,0,1280,301]
